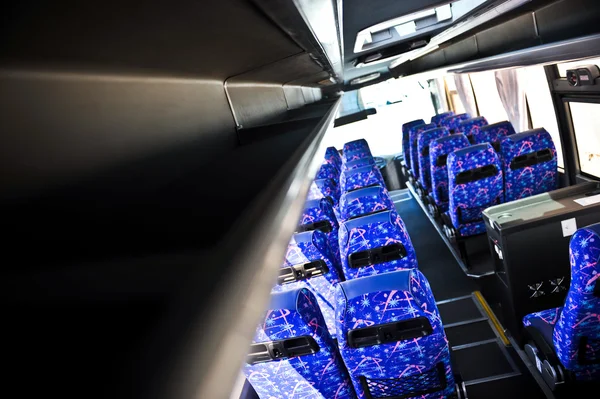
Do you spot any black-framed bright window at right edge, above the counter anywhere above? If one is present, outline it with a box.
[569,102,600,178]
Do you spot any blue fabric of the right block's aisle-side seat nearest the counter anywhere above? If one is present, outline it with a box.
[448,144,502,237]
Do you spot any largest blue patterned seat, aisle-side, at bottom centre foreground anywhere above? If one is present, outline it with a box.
[336,269,455,399]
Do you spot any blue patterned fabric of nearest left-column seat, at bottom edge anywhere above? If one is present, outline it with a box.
[244,288,356,399]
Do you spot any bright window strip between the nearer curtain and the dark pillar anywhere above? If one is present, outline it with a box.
[519,66,565,168]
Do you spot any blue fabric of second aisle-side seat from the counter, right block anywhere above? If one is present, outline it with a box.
[429,134,469,212]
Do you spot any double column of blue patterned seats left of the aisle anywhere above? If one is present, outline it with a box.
[244,140,455,399]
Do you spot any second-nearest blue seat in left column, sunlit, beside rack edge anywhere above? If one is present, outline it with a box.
[271,230,344,336]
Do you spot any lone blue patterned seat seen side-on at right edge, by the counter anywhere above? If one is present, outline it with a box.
[523,223,600,381]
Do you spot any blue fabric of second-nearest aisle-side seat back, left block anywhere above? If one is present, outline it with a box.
[339,210,417,280]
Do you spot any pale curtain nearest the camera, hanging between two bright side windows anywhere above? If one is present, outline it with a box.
[496,69,529,133]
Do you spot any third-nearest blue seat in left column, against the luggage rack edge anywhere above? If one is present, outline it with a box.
[297,198,340,259]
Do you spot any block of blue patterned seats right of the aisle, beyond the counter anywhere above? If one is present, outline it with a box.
[402,113,558,237]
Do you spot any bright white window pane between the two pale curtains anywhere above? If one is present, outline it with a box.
[470,71,508,124]
